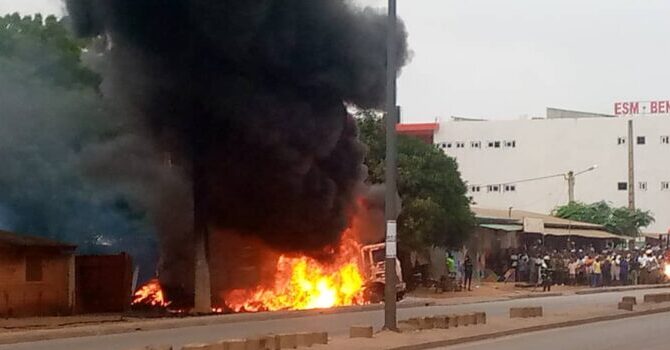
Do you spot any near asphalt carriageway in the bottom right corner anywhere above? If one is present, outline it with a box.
[442,313,670,350]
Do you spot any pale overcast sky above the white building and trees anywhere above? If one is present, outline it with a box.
[0,0,670,122]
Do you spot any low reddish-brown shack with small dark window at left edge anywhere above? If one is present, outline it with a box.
[0,230,76,317]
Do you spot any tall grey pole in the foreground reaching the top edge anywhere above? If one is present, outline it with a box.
[384,0,398,331]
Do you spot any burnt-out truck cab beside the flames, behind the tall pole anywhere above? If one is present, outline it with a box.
[361,243,407,303]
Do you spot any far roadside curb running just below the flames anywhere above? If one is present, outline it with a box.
[0,302,435,345]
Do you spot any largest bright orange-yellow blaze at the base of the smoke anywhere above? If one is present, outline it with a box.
[224,234,365,312]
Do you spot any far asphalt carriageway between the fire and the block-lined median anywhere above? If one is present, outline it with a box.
[5,289,670,350]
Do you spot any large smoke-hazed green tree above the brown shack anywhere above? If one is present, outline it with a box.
[0,14,153,262]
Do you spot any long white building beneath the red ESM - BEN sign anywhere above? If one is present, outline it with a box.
[434,109,670,233]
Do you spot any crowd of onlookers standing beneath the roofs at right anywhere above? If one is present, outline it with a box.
[501,247,670,291]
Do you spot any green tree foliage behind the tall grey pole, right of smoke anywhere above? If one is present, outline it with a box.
[358,111,474,249]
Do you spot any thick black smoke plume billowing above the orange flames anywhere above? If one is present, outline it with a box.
[66,0,407,300]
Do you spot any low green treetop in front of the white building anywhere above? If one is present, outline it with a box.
[553,201,654,237]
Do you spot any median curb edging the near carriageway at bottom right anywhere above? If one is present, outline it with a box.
[388,306,670,350]
